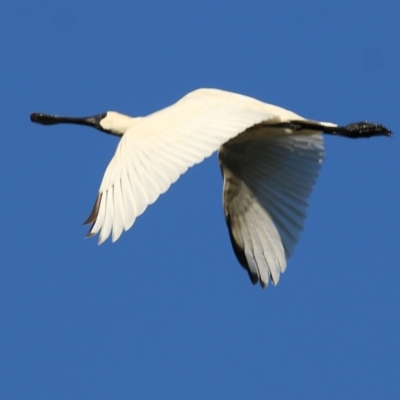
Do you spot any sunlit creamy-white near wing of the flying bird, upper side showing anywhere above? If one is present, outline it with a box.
[86,89,302,243]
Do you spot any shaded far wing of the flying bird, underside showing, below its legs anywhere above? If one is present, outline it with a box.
[219,128,324,287]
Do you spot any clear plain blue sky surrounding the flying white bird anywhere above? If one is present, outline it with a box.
[0,0,400,399]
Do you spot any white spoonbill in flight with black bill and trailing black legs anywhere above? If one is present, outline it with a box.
[30,88,392,288]
